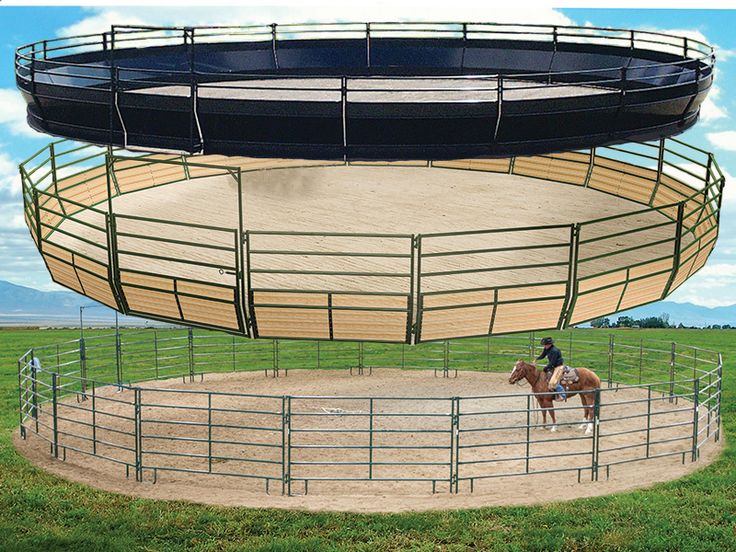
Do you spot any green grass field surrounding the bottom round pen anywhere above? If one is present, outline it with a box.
[0,330,736,552]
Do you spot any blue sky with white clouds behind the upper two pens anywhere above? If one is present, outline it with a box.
[0,2,736,307]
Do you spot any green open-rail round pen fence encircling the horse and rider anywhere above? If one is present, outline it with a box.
[18,330,722,495]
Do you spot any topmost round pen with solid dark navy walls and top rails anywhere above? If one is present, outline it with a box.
[15,22,715,156]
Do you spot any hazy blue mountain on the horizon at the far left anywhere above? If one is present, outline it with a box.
[0,280,162,326]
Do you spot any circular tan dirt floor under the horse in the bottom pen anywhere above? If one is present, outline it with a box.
[16,368,722,512]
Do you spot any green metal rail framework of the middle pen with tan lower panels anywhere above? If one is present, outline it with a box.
[20,138,725,343]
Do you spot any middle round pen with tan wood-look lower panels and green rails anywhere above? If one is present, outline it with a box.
[21,139,725,343]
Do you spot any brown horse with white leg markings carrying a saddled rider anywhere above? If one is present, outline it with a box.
[509,360,601,435]
